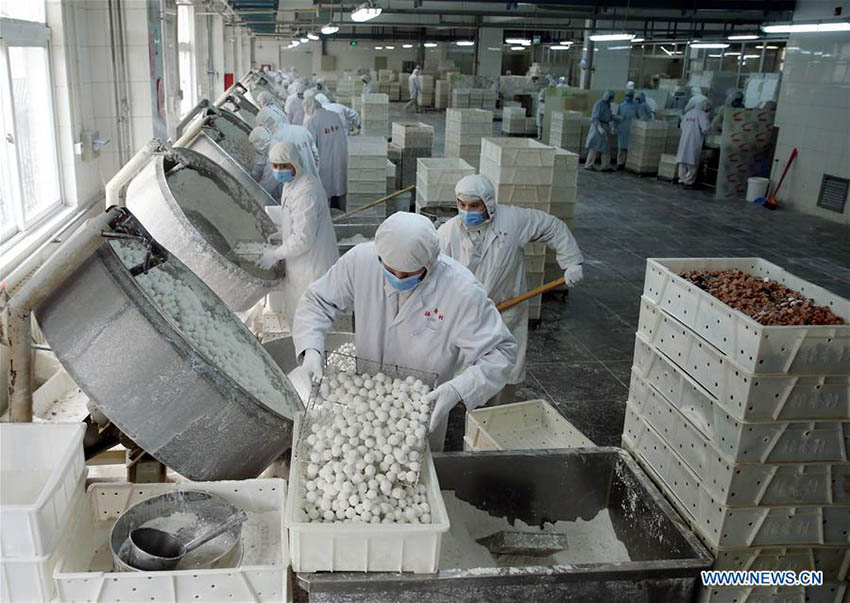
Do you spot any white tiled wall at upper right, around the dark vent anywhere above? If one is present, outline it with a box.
[771,0,850,224]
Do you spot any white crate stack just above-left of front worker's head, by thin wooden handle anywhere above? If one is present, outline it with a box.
[345,136,387,218]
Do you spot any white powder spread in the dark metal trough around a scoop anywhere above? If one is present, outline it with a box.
[440,490,631,569]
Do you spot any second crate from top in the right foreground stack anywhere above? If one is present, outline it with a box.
[634,297,850,419]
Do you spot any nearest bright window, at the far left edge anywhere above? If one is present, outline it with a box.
[0,2,62,243]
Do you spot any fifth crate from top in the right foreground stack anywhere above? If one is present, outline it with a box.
[623,416,850,552]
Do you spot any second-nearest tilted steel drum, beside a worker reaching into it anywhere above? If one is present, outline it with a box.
[127,148,283,311]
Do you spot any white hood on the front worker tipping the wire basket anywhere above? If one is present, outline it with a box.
[375,211,440,272]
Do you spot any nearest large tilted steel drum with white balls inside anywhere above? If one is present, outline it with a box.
[36,212,302,481]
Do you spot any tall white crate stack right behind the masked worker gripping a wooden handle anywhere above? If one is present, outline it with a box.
[480,138,555,320]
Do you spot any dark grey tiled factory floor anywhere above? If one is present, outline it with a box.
[390,104,850,450]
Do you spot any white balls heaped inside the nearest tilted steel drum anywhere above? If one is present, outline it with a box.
[112,240,293,416]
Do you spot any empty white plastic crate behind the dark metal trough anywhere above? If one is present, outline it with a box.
[464,400,594,452]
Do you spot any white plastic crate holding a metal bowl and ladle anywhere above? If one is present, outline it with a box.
[55,479,289,603]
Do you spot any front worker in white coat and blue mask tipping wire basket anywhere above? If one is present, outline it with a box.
[292,212,516,450]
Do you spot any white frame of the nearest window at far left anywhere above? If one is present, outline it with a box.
[0,17,66,248]
